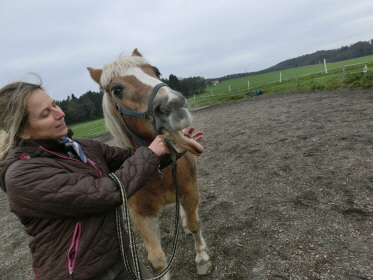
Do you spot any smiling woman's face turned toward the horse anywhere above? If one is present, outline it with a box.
[20,89,67,139]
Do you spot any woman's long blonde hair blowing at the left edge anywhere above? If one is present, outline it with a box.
[0,78,43,160]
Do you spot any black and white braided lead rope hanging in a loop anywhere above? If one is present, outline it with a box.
[109,154,180,280]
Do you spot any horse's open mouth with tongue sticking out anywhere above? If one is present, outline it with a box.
[163,129,204,156]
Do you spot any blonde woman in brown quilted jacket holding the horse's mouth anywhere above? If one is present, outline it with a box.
[0,82,203,280]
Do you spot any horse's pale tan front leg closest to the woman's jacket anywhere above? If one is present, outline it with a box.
[131,209,170,280]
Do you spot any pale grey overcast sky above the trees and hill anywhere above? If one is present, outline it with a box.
[0,0,373,100]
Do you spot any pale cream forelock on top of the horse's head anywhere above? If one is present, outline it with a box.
[100,55,148,88]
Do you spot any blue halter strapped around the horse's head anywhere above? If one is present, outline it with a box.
[112,83,167,146]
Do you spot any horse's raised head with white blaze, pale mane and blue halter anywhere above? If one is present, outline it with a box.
[87,49,203,155]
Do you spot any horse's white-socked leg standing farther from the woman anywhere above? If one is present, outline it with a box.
[181,200,212,275]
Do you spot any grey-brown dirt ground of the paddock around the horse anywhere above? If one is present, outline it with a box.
[0,89,373,280]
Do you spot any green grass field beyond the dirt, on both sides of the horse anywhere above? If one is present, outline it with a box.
[69,55,373,138]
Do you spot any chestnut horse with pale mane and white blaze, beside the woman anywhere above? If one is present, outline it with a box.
[87,49,212,280]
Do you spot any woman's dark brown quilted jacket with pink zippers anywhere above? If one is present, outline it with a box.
[0,139,160,280]
